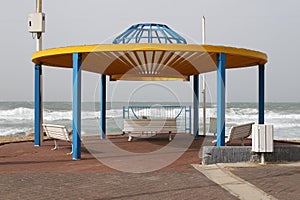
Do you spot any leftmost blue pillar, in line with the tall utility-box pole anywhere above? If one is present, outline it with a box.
[34,64,43,146]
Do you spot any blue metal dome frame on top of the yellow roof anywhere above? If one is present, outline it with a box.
[113,23,187,44]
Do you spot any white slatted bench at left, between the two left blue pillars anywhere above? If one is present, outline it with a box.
[43,124,73,154]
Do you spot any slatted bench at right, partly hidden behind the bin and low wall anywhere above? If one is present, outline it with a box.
[212,122,254,146]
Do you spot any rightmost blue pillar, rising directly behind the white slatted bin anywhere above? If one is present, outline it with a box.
[258,65,265,124]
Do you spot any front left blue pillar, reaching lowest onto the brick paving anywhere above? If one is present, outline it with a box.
[72,53,82,160]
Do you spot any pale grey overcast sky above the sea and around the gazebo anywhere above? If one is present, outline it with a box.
[0,0,300,102]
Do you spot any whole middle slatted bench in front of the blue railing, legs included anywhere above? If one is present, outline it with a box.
[123,119,177,141]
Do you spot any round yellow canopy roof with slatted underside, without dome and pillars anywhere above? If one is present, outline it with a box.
[32,44,268,80]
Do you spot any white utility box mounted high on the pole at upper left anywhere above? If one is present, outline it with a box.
[28,13,45,33]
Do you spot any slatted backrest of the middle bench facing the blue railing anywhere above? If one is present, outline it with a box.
[123,119,177,133]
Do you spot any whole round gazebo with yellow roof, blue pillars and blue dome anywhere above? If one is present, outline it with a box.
[32,24,267,160]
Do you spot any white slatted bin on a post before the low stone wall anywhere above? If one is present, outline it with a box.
[252,124,273,152]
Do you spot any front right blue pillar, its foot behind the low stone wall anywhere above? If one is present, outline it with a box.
[217,53,226,146]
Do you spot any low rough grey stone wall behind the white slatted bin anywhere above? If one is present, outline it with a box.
[202,145,300,165]
